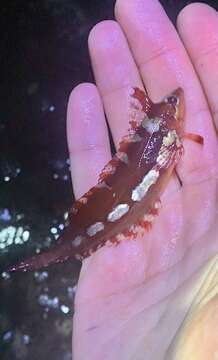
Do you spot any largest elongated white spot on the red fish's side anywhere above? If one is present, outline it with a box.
[132,169,159,201]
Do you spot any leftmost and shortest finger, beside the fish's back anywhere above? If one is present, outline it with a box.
[67,84,111,198]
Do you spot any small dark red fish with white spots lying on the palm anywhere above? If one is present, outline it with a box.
[9,88,203,271]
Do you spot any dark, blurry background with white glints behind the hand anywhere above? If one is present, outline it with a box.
[0,0,218,360]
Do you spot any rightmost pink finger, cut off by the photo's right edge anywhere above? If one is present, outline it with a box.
[177,4,218,130]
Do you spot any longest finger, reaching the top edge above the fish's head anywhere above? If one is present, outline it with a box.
[116,0,216,183]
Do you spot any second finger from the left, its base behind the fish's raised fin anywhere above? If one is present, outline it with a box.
[89,21,143,146]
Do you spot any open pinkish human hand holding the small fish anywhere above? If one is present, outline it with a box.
[67,0,218,360]
